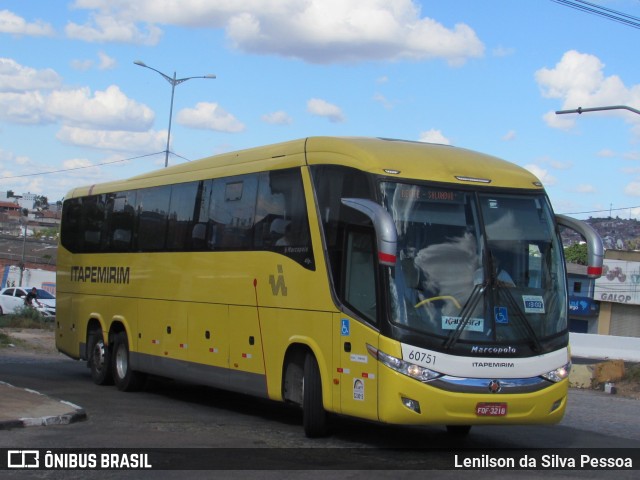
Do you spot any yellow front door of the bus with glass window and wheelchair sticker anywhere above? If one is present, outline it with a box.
[334,228,379,420]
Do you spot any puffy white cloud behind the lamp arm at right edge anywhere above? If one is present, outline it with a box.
[535,50,640,134]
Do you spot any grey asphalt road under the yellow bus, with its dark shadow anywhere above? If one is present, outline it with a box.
[0,355,640,479]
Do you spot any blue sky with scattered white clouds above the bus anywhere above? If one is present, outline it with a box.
[0,0,640,219]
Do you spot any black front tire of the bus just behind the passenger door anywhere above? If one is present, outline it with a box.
[302,353,328,438]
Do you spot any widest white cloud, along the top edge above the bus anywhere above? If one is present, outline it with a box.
[67,0,484,65]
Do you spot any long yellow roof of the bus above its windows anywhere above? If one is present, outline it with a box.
[66,137,542,198]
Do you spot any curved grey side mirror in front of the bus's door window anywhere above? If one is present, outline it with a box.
[342,198,398,267]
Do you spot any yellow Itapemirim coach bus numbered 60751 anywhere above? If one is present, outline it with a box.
[56,137,603,437]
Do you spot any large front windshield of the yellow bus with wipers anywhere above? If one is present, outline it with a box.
[381,182,567,350]
